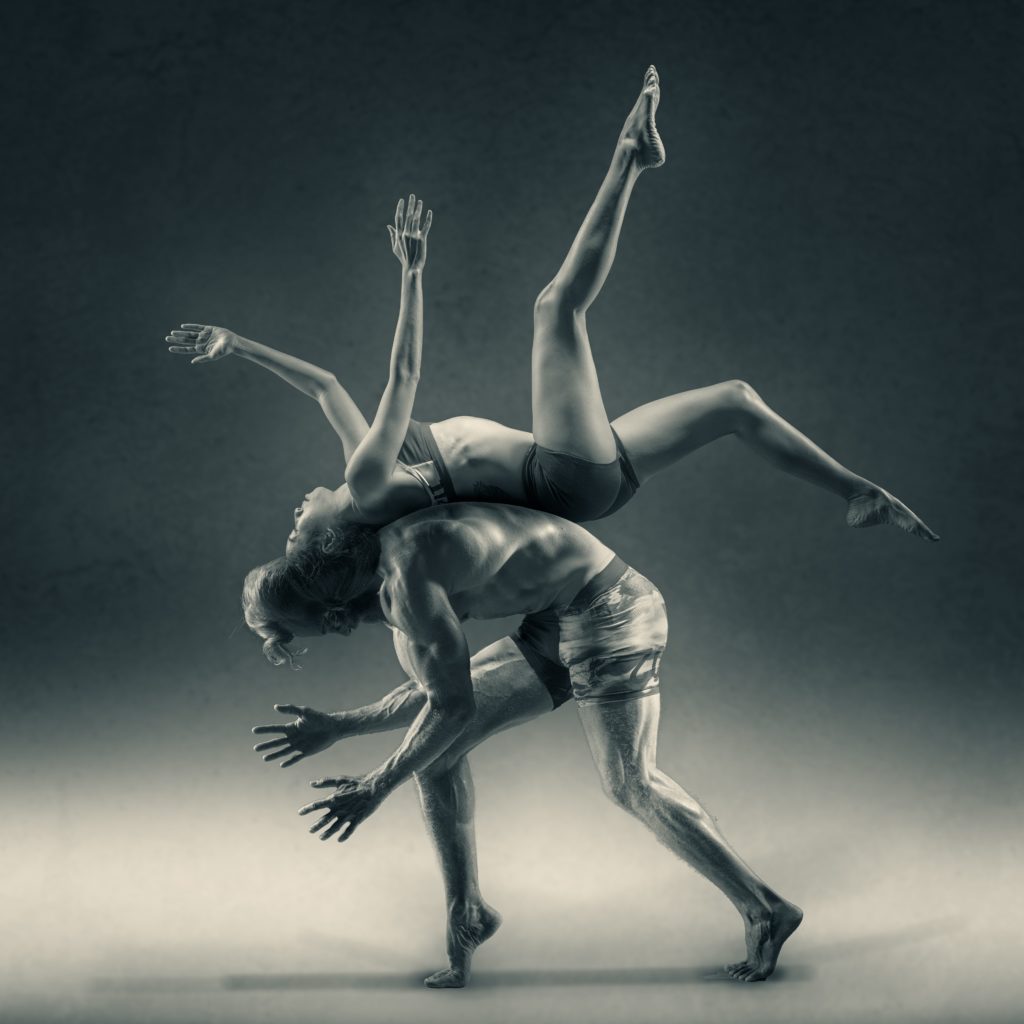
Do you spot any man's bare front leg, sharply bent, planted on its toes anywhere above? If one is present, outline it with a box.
[416,637,552,988]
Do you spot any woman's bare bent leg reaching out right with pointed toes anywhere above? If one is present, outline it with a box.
[612,380,939,541]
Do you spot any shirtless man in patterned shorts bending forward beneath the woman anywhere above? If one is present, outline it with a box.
[246,503,803,987]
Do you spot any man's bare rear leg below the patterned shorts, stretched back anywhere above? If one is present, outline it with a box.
[579,693,803,981]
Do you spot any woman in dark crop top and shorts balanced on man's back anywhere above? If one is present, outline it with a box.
[167,67,938,664]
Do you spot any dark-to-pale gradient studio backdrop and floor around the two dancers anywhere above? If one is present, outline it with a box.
[0,0,1024,1022]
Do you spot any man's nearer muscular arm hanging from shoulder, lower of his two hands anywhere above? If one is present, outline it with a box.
[299,564,476,842]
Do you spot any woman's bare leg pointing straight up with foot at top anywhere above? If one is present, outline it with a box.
[532,67,665,463]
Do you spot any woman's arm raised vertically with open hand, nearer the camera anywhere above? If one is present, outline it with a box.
[345,196,433,505]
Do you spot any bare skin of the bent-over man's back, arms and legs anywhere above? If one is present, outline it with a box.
[259,503,800,987]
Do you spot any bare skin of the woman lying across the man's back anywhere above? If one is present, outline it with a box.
[167,67,938,551]
